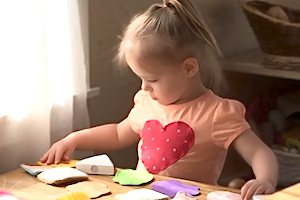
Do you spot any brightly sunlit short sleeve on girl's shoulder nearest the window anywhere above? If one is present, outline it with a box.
[127,90,145,134]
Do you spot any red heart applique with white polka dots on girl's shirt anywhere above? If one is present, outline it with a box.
[141,120,195,174]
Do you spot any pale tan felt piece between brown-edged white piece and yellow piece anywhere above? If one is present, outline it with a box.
[66,181,110,198]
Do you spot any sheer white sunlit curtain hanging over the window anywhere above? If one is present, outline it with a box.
[0,0,89,174]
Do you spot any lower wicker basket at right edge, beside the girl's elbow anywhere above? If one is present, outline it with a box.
[273,149,300,187]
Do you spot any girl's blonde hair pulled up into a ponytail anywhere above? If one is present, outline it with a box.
[117,0,223,90]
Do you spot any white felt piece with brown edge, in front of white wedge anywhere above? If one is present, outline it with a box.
[37,167,88,185]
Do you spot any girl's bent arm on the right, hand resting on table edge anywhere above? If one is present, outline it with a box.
[233,129,278,200]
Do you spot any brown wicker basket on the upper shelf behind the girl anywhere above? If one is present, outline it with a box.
[241,0,300,65]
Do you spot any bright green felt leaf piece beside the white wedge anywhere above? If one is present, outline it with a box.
[113,169,153,185]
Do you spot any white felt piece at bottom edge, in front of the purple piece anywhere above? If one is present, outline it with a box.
[115,189,169,200]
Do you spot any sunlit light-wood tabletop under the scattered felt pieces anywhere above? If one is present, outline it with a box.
[0,169,240,200]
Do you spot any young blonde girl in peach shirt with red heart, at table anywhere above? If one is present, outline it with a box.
[41,0,278,199]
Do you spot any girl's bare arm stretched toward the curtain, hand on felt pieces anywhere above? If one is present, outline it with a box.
[40,119,139,164]
